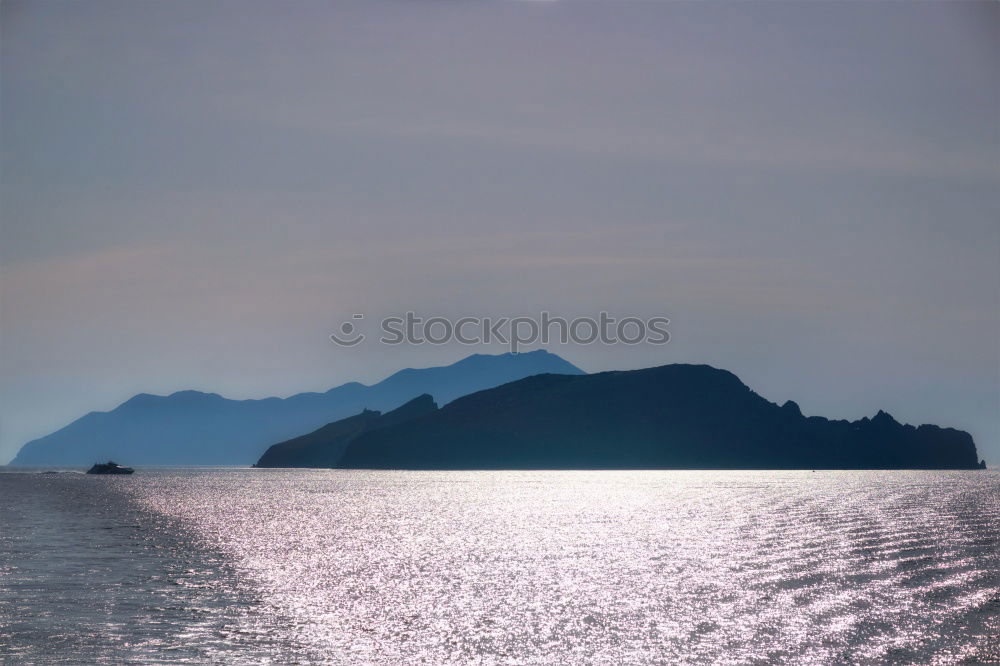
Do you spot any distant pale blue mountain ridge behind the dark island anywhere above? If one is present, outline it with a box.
[11,350,585,466]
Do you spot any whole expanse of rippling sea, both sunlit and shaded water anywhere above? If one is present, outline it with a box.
[0,468,1000,666]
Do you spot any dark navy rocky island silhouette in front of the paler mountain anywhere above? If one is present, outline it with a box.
[258,364,985,470]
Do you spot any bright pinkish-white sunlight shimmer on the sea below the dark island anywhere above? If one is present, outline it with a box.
[0,470,1000,664]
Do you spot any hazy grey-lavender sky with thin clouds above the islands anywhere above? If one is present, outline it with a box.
[0,0,1000,464]
